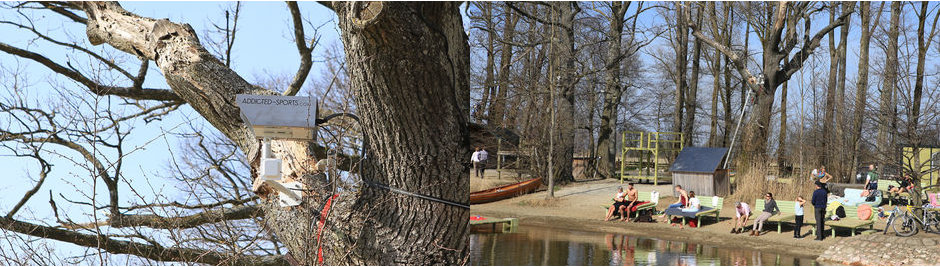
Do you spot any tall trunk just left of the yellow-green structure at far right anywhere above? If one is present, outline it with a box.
[877,2,901,170]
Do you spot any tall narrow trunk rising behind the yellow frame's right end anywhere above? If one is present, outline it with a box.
[673,2,689,136]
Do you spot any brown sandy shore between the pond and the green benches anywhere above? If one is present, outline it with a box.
[470,170,925,258]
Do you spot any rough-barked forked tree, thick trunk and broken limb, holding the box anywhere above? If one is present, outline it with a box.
[82,2,470,265]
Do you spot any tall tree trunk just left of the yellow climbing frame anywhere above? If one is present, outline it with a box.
[597,1,631,178]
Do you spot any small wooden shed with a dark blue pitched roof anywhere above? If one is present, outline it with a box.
[669,147,731,196]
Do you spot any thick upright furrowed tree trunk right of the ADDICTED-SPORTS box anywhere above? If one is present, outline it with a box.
[328,2,470,265]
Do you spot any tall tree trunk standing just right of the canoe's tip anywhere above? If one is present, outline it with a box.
[548,2,580,191]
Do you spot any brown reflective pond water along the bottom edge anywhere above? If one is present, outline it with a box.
[470,225,816,266]
